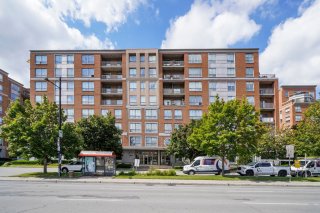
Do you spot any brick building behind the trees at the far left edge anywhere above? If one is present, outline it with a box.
[0,69,29,158]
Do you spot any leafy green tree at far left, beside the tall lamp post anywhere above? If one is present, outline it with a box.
[1,97,81,173]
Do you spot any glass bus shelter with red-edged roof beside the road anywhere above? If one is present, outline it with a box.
[79,151,116,176]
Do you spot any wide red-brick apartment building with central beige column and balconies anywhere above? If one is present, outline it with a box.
[30,49,279,165]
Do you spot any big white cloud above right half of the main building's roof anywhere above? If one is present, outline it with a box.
[162,0,266,48]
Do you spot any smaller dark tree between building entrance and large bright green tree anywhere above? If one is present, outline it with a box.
[166,120,204,160]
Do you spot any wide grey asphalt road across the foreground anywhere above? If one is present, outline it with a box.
[0,181,320,213]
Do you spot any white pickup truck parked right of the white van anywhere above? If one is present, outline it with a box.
[237,162,290,177]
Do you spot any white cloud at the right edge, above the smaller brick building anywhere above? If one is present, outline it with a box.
[260,0,320,84]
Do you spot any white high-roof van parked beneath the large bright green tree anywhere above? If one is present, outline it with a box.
[182,156,230,175]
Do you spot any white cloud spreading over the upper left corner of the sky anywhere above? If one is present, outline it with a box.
[0,0,145,86]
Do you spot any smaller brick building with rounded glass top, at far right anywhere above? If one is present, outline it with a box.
[279,85,317,128]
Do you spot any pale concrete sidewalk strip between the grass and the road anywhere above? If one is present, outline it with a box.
[0,177,320,187]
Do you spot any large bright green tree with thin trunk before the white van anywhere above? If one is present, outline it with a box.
[188,97,265,175]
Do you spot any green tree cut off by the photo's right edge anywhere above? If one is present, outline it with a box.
[295,101,320,156]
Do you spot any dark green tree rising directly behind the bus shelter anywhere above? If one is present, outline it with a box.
[78,113,122,157]
